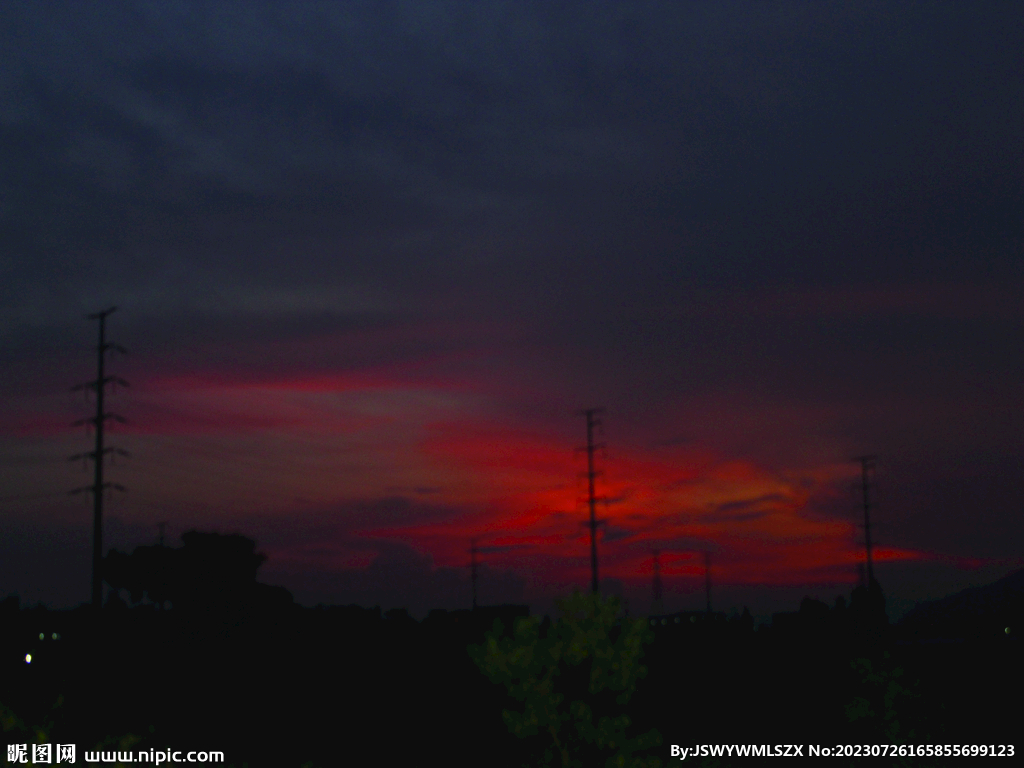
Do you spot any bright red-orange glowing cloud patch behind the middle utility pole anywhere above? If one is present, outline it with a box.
[368,422,924,584]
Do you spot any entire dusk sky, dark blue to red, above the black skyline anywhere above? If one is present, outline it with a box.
[0,0,1024,617]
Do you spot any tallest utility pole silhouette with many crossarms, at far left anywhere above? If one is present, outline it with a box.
[71,307,128,610]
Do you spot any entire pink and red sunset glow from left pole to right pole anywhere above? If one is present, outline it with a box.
[22,360,929,585]
